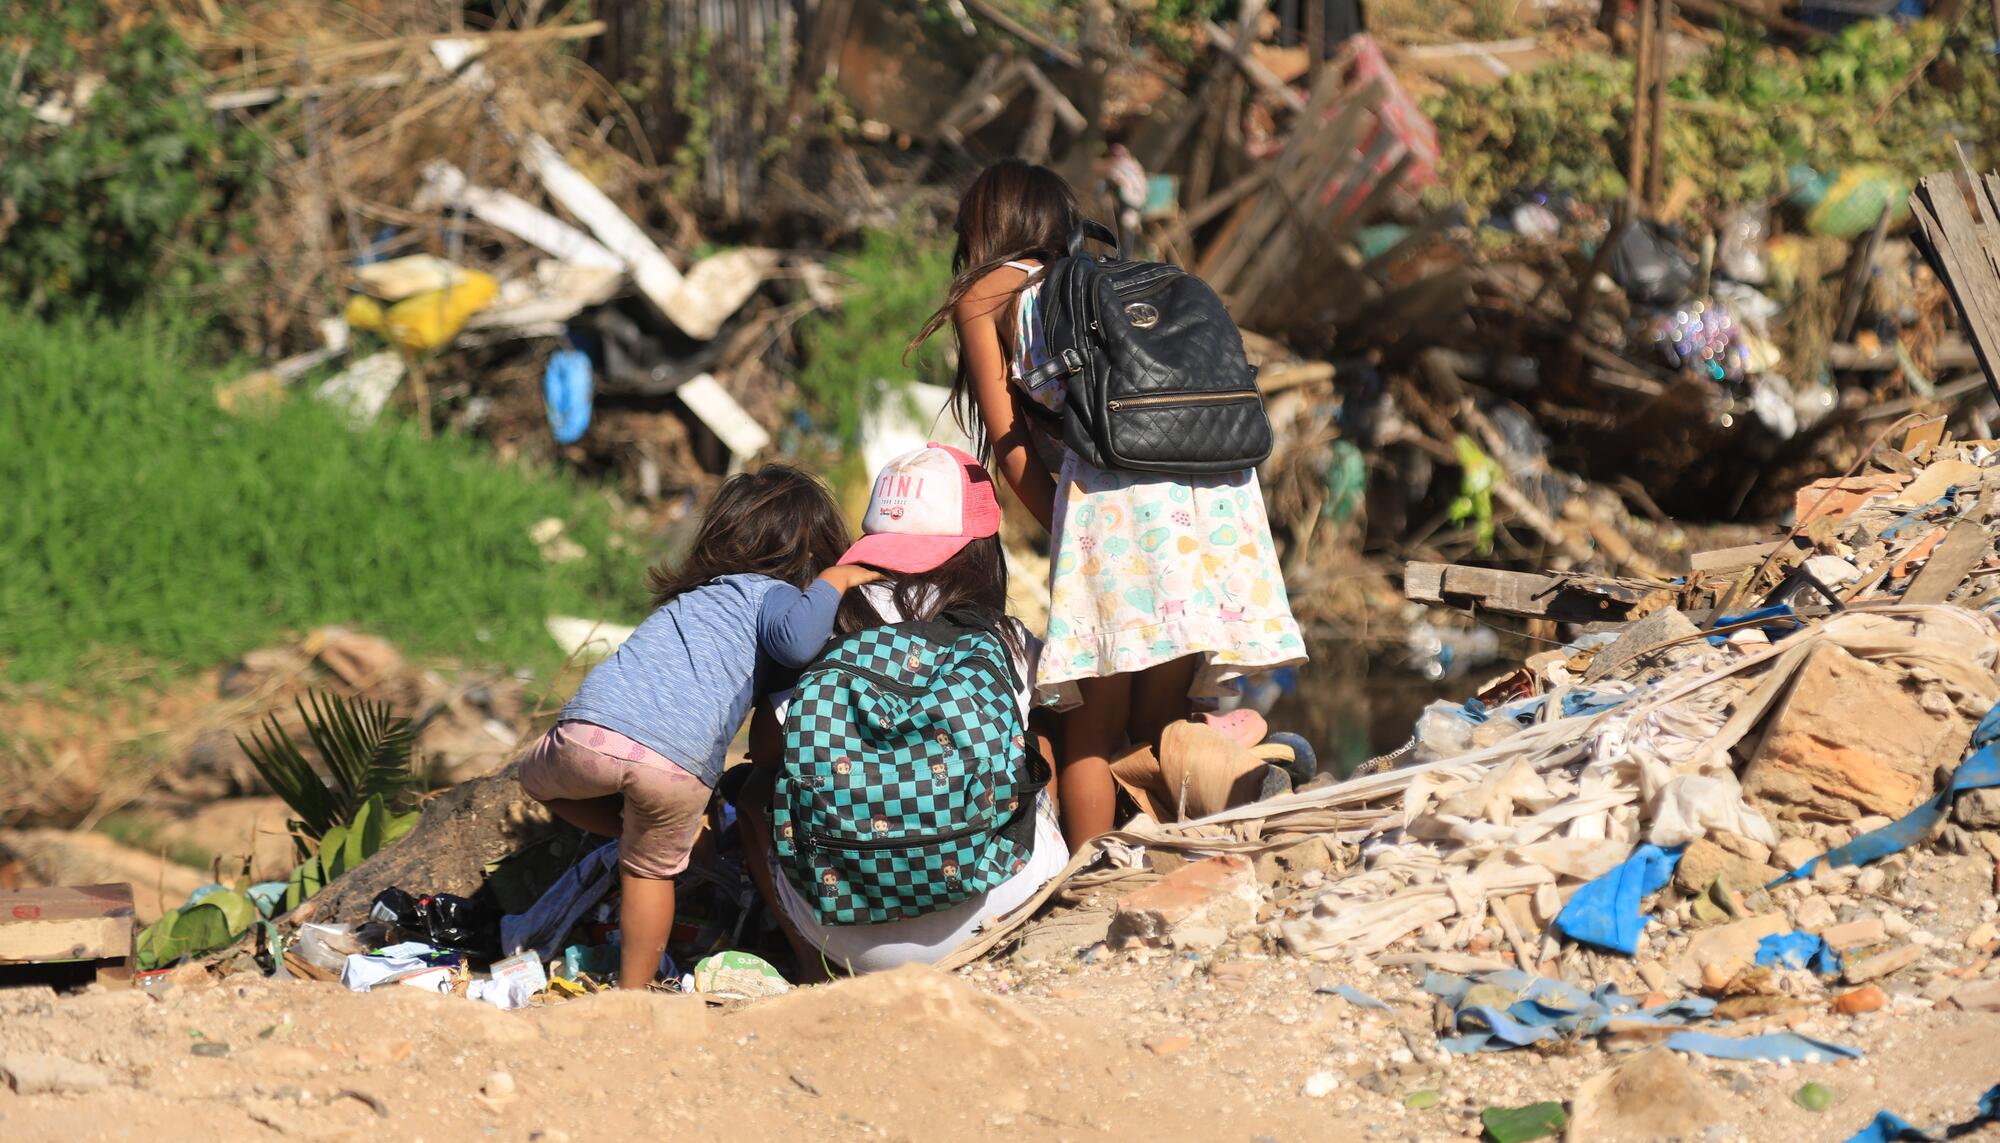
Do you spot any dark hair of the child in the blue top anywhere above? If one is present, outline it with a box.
[646,464,848,607]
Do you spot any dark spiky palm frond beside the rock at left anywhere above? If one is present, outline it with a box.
[236,691,416,853]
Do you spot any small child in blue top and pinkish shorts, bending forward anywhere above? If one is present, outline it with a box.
[520,464,878,989]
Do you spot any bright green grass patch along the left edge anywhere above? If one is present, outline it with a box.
[0,314,644,683]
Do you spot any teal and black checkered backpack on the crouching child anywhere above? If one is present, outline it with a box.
[772,611,1048,925]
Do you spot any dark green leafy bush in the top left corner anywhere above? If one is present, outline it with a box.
[0,0,260,321]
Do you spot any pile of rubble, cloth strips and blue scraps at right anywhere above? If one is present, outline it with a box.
[954,426,2000,1059]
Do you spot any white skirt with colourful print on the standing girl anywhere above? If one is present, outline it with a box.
[1036,450,1306,707]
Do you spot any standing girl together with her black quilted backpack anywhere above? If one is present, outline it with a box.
[910,160,1306,849]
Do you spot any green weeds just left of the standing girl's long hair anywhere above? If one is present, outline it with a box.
[798,226,952,446]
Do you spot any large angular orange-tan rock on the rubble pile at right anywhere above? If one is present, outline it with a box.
[1742,645,1972,821]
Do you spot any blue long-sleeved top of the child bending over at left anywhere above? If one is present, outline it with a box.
[560,575,840,785]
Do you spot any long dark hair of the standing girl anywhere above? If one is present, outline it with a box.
[904,158,1082,462]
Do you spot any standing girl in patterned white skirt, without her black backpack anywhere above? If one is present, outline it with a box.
[910,160,1306,847]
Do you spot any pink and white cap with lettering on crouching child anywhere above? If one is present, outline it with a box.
[840,444,1000,573]
